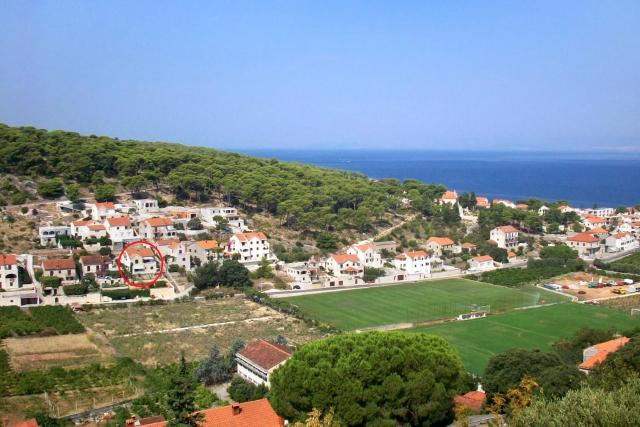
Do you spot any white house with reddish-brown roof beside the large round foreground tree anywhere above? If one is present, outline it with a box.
[236,340,291,387]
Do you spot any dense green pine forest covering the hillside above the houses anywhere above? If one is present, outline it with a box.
[0,124,444,231]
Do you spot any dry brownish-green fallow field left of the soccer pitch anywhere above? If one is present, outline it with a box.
[77,298,321,366]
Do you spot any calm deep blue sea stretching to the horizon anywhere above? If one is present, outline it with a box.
[239,150,640,207]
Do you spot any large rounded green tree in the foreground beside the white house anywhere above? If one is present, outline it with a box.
[269,332,463,426]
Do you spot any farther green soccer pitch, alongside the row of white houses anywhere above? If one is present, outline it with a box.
[287,279,567,330]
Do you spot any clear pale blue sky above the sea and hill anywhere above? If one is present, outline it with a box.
[0,0,640,150]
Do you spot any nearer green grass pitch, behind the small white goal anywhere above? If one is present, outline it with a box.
[411,303,640,373]
